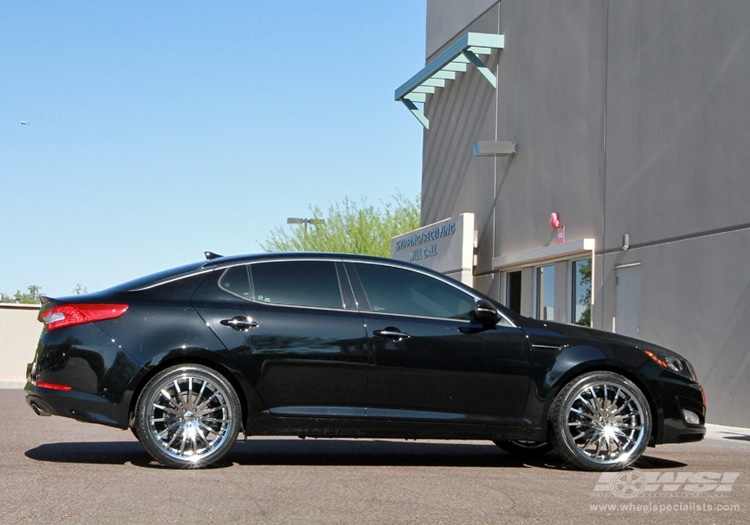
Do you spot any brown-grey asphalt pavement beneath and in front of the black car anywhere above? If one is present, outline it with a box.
[0,390,750,524]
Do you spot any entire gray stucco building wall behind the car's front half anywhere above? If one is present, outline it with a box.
[424,0,750,426]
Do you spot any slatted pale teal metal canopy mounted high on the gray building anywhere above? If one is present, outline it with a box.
[395,33,505,129]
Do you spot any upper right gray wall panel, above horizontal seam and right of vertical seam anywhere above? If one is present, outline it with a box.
[605,0,750,248]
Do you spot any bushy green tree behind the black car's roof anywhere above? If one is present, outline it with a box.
[261,193,420,257]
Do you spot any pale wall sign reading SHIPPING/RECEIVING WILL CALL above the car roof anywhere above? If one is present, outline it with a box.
[391,213,474,286]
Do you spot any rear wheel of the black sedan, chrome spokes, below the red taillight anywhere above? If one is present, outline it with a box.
[134,365,242,468]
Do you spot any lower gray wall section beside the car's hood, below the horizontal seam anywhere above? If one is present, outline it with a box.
[599,229,750,427]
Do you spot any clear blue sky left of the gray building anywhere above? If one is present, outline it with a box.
[0,0,426,296]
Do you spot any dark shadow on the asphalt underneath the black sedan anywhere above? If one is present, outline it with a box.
[25,438,687,470]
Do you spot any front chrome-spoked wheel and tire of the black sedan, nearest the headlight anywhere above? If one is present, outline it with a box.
[550,372,651,471]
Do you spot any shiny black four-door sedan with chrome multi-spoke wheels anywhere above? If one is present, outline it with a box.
[26,252,706,470]
